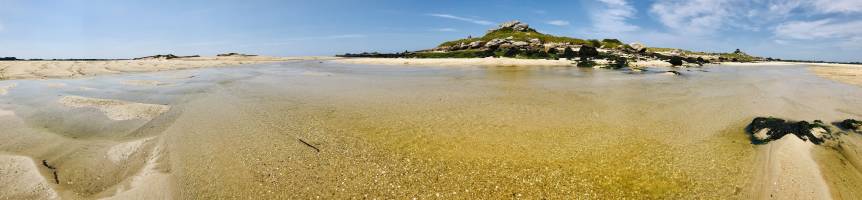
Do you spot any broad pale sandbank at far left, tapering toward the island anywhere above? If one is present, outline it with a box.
[0,56,333,80]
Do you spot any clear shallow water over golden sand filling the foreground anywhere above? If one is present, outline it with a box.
[0,61,862,199]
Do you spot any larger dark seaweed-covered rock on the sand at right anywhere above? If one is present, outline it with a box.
[745,117,832,145]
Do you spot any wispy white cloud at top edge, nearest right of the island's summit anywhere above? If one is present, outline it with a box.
[590,0,640,33]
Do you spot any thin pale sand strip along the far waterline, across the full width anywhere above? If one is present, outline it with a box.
[0,56,862,87]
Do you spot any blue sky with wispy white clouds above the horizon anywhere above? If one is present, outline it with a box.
[0,0,862,61]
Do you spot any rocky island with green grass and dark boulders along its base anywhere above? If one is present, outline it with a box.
[338,20,769,69]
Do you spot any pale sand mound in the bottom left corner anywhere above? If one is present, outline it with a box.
[0,155,59,199]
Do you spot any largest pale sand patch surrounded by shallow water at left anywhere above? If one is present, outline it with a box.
[58,96,170,120]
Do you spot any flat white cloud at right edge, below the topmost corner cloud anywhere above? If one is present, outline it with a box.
[775,19,862,40]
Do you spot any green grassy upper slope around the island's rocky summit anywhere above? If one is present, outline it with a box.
[439,28,587,47]
